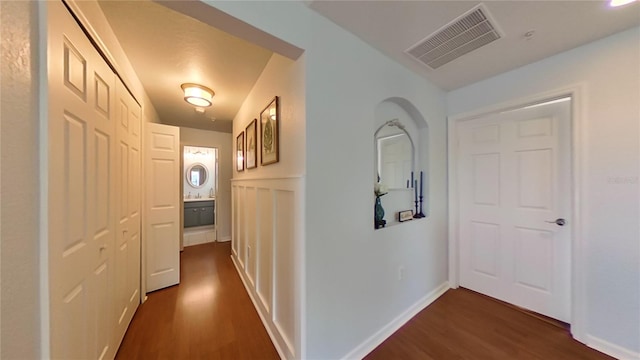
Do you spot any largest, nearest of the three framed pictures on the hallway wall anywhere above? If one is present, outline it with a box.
[260,96,280,165]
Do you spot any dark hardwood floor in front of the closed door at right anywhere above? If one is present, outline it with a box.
[365,289,612,360]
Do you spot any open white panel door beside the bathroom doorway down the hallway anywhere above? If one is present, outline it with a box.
[144,123,182,292]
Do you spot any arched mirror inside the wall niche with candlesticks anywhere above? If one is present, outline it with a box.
[374,119,415,189]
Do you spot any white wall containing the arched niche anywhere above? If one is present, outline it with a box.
[206,2,447,359]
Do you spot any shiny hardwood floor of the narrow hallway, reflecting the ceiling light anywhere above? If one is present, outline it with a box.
[116,242,279,359]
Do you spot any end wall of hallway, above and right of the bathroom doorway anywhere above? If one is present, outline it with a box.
[180,127,235,241]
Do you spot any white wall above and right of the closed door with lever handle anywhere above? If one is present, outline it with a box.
[447,28,640,358]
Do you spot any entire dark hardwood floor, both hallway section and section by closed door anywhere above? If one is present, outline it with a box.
[116,243,611,360]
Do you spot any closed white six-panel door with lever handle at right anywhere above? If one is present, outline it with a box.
[457,101,571,322]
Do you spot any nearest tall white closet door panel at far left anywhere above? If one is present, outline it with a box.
[44,2,116,359]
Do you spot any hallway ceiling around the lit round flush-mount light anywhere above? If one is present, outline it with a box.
[99,0,272,132]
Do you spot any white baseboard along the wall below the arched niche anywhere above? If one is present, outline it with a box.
[342,281,449,360]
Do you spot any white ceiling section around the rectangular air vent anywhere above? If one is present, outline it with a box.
[308,0,640,90]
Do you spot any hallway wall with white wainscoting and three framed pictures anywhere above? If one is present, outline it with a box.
[233,54,305,358]
